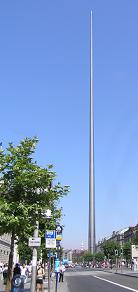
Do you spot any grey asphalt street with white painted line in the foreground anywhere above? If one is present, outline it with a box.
[60,271,138,292]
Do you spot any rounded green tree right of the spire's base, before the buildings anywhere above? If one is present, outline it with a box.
[102,240,119,259]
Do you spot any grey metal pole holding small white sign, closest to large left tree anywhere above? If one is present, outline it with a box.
[30,221,39,292]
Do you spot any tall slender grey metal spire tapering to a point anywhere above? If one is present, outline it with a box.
[88,11,95,253]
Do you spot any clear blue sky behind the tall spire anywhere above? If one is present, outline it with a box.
[0,0,138,248]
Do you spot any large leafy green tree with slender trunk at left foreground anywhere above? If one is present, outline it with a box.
[0,137,68,291]
